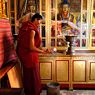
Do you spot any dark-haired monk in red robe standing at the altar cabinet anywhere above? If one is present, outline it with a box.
[17,13,45,95]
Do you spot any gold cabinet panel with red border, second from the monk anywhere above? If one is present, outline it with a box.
[55,60,69,82]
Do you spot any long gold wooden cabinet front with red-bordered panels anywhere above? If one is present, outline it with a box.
[40,53,95,89]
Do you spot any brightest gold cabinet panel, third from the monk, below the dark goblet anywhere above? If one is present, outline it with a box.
[72,60,86,82]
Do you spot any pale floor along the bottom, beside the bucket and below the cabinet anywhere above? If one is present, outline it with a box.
[40,90,95,95]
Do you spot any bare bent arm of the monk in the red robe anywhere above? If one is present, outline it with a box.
[30,30,45,53]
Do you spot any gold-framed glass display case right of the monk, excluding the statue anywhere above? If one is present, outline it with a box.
[40,0,95,50]
